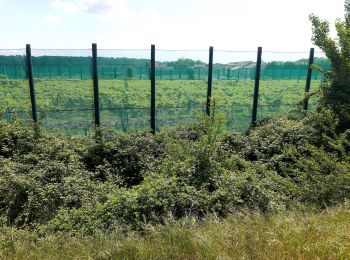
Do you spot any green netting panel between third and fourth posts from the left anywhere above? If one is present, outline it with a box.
[156,50,209,131]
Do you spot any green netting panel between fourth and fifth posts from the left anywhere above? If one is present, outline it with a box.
[212,51,256,131]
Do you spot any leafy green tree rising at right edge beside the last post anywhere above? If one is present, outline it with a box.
[309,0,350,131]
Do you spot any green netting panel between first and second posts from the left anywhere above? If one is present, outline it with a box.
[32,49,93,134]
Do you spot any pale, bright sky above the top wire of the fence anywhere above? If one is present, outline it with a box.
[0,0,343,51]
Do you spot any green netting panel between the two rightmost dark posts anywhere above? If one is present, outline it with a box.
[257,52,309,120]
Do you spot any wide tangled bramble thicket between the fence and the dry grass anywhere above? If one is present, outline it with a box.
[0,106,350,234]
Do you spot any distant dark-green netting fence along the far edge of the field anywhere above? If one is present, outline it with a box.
[0,57,329,80]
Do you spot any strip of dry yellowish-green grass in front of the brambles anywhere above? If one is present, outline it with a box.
[0,204,350,259]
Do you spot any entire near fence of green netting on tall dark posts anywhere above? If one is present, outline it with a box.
[0,45,329,133]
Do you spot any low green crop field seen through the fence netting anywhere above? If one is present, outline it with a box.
[0,79,320,134]
